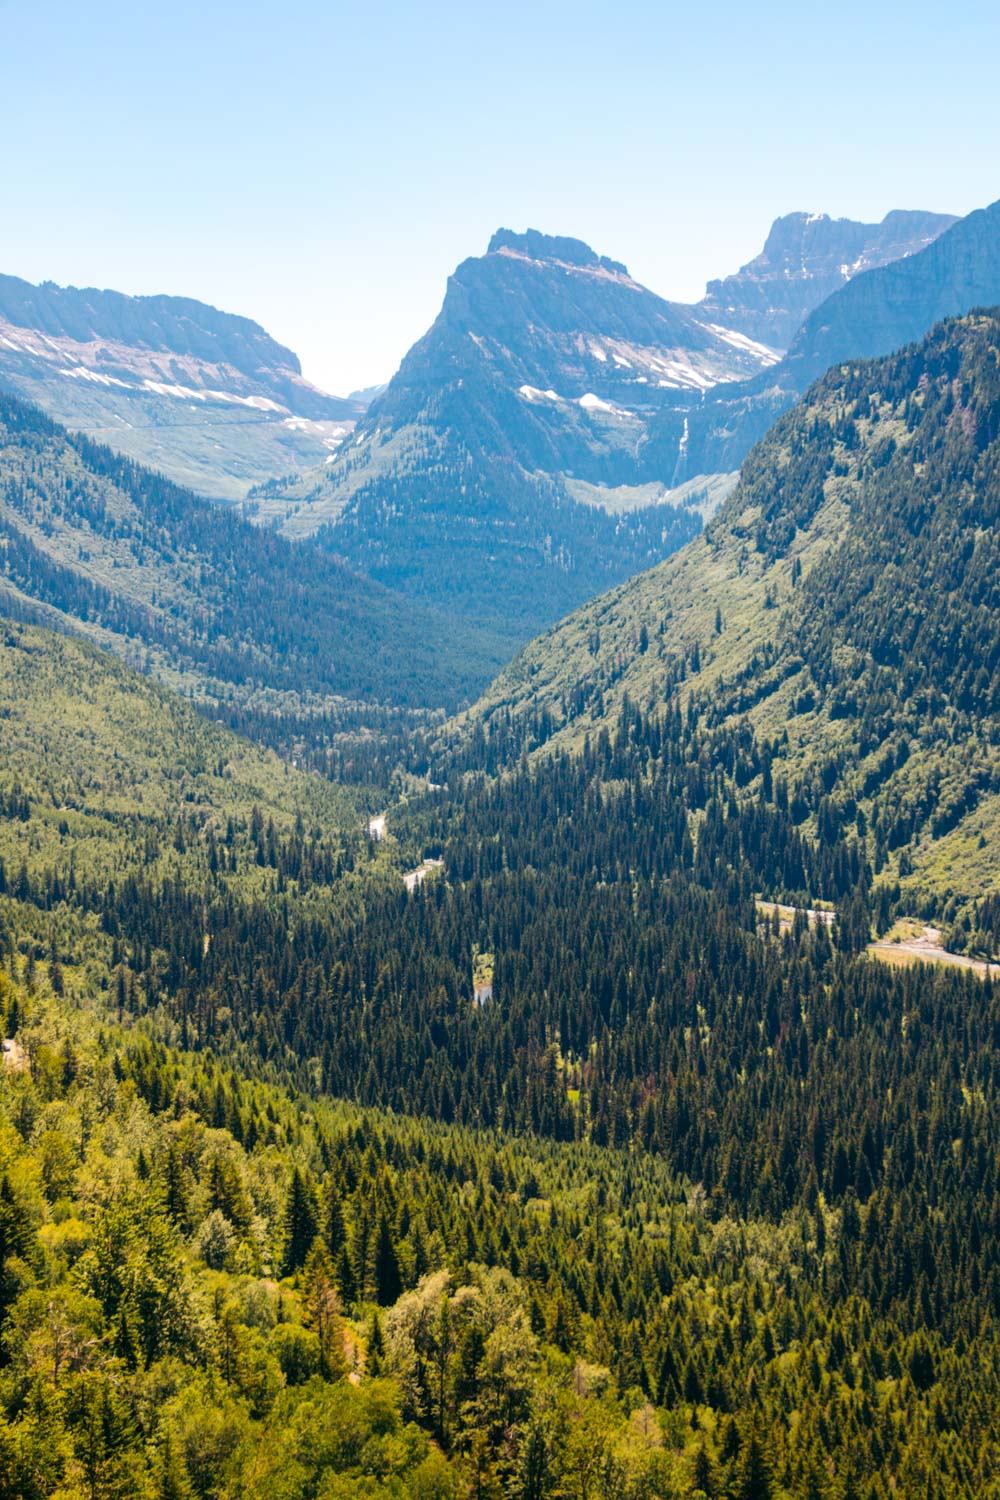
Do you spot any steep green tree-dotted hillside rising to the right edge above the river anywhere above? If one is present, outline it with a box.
[454,312,1000,926]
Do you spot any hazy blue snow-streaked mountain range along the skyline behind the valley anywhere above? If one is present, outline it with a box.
[0,212,961,665]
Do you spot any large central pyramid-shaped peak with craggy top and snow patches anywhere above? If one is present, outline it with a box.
[262,230,778,647]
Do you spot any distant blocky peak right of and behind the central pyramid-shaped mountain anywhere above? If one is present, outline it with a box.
[697,209,957,350]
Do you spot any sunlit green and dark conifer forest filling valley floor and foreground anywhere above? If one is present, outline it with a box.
[0,606,1000,1500]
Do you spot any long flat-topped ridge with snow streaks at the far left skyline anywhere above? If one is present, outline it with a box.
[0,276,363,500]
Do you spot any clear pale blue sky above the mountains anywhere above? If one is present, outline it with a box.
[0,0,1000,390]
